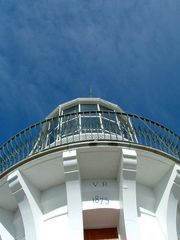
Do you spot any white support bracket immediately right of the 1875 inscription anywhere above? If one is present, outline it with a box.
[119,149,140,240]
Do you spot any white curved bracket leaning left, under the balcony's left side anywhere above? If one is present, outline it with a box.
[7,170,43,240]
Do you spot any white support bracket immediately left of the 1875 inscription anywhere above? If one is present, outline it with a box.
[63,150,84,240]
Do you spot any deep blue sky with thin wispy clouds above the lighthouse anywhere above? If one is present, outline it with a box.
[0,0,180,143]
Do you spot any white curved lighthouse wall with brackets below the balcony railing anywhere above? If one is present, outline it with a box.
[0,144,180,240]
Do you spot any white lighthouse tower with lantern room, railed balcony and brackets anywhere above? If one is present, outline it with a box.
[0,98,180,240]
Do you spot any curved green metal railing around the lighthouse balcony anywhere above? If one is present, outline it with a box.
[0,111,180,173]
